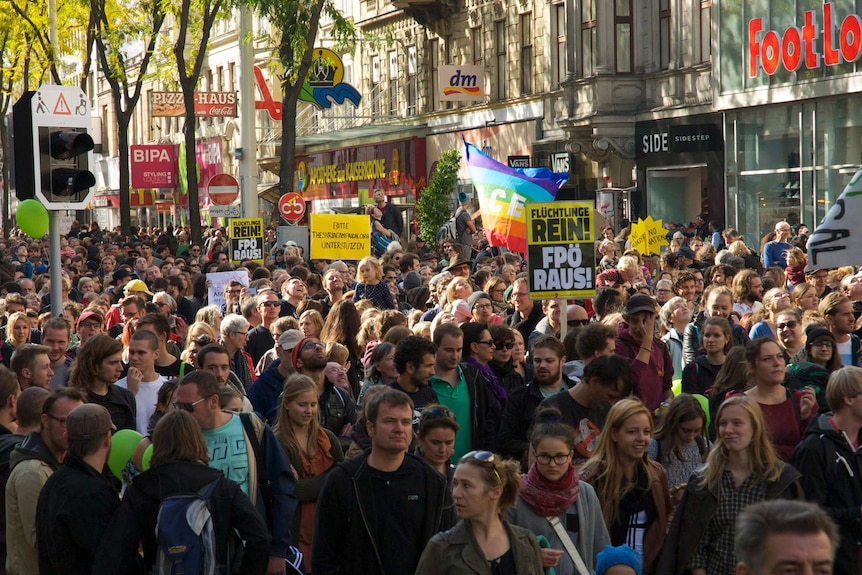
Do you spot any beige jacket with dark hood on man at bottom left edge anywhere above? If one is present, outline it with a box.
[6,431,60,575]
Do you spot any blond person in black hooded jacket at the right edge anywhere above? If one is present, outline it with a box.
[790,366,862,573]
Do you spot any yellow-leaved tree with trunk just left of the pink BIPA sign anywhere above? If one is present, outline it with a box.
[90,0,165,236]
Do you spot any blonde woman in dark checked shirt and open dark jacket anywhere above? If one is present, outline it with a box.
[658,396,804,575]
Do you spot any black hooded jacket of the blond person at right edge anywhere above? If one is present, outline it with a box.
[790,413,862,573]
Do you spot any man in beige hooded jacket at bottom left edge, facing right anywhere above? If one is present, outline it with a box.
[6,387,86,575]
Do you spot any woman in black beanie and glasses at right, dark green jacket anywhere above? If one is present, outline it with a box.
[784,324,841,413]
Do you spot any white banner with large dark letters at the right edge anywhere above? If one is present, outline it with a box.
[807,170,862,270]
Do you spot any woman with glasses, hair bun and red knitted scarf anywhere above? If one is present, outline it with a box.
[509,408,611,575]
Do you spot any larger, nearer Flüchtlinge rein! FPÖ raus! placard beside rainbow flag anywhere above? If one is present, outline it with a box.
[527,202,596,300]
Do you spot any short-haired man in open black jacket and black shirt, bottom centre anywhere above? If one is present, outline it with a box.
[318,389,451,575]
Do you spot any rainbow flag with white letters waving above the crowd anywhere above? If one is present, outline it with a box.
[464,140,569,254]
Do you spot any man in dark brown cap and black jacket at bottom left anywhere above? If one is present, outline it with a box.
[36,404,120,575]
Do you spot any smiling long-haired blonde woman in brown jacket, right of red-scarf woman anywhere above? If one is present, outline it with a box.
[581,399,673,573]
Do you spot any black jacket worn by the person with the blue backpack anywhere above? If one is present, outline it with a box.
[93,461,269,575]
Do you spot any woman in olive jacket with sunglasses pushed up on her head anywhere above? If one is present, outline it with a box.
[416,451,544,575]
